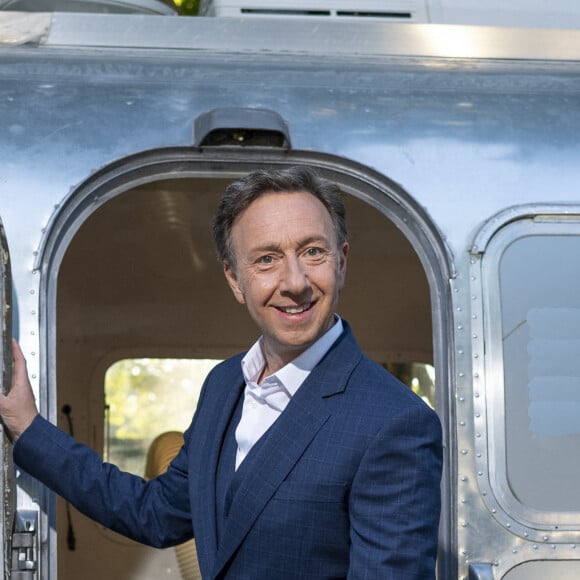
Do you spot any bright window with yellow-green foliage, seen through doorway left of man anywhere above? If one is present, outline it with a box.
[103,358,220,476]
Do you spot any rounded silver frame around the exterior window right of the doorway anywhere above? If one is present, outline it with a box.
[470,205,580,542]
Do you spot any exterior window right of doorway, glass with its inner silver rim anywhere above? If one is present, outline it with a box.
[484,219,580,529]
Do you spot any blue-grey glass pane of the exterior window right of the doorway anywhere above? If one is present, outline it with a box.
[500,236,580,511]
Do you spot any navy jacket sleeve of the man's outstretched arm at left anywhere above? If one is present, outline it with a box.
[14,416,193,547]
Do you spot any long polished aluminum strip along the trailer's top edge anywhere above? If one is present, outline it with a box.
[45,13,580,60]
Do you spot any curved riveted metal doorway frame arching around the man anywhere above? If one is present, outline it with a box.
[35,147,457,579]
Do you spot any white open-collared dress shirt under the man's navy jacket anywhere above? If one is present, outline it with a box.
[236,316,343,469]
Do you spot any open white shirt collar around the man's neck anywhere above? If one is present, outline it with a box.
[242,314,344,396]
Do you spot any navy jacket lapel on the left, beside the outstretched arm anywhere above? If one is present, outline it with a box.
[190,356,244,577]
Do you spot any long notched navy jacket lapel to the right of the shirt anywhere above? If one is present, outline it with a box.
[212,324,361,577]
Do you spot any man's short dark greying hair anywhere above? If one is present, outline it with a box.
[213,166,346,267]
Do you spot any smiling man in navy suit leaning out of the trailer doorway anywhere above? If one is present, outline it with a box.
[0,167,441,580]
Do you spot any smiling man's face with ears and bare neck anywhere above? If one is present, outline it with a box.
[224,192,348,373]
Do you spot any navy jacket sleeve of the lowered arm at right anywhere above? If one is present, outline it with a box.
[348,404,442,580]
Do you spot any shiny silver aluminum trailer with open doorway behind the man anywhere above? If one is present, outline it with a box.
[0,7,580,580]
